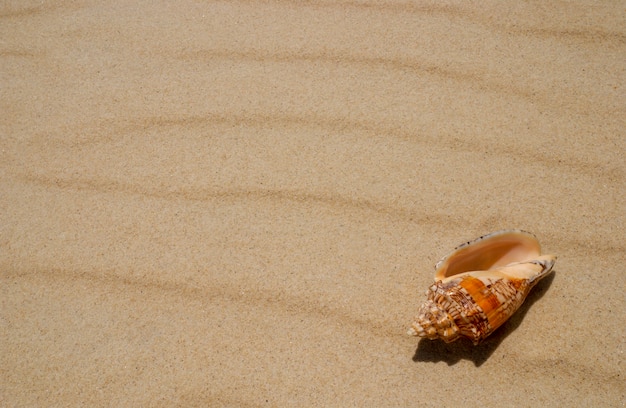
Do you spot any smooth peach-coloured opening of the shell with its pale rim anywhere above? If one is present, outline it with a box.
[435,230,541,280]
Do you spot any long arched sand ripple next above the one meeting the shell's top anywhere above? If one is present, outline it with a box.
[22,112,626,182]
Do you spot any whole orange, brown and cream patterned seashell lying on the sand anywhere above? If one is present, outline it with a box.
[408,230,556,344]
